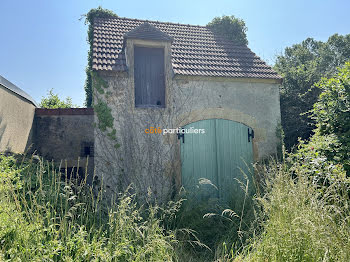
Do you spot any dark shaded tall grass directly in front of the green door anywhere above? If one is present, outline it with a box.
[176,171,255,261]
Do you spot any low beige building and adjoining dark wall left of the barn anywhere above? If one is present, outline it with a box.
[0,76,94,179]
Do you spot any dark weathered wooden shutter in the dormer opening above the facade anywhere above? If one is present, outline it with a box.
[134,47,165,107]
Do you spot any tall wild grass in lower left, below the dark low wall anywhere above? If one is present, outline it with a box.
[0,155,177,261]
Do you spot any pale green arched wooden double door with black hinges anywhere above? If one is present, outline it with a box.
[181,119,253,202]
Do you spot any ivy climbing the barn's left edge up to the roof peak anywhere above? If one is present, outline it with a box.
[84,6,118,107]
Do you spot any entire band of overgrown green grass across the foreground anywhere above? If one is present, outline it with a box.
[0,146,350,262]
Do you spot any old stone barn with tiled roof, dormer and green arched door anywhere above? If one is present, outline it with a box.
[92,18,282,202]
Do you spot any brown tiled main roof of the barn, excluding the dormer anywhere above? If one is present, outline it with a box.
[92,17,282,79]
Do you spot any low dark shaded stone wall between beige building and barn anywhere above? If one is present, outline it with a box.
[32,108,94,181]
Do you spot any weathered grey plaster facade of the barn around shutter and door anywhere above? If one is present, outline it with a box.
[94,39,280,199]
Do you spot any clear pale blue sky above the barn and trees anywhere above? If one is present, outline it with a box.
[0,0,350,106]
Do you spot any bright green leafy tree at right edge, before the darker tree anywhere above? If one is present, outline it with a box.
[312,62,350,176]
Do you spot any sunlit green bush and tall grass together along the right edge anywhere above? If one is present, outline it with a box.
[231,63,350,261]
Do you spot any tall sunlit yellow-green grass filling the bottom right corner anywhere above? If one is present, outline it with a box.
[219,160,350,262]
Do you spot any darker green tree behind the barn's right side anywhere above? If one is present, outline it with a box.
[274,34,350,149]
